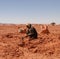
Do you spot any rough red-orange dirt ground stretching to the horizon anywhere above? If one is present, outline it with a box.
[0,24,60,59]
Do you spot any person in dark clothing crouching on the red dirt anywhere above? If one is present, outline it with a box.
[26,24,37,39]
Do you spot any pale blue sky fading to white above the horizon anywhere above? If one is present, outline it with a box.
[0,0,60,24]
